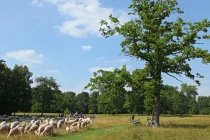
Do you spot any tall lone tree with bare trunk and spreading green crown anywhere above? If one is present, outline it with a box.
[100,0,210,127]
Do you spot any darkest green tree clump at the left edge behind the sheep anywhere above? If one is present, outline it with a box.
[0,60,32,115]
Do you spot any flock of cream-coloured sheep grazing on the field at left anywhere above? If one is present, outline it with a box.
[0,116,93,138]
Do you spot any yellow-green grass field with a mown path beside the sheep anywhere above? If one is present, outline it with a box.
[0,115,210,140]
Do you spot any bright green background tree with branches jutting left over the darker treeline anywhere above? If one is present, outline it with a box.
[85,66,130,114]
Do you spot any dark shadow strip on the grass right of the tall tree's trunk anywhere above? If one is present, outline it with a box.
[161,124,209,129]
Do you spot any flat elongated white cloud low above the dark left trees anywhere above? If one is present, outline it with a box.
[6,50,45,63]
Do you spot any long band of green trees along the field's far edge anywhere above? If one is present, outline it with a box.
[0,60,210,115]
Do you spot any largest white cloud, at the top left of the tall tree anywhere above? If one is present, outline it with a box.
[34,0,129,37]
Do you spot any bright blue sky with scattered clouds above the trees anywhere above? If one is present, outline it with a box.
[0,0,210,96]
